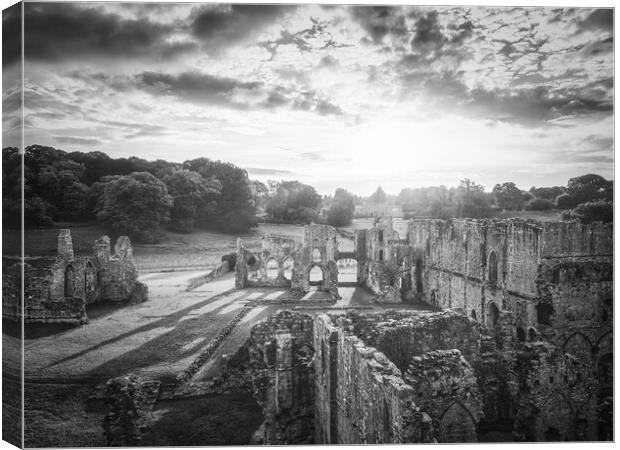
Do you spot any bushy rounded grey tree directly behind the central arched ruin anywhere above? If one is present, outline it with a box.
[266,181,321,223]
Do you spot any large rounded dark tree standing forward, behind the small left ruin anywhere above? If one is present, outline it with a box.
[96,172,174,242]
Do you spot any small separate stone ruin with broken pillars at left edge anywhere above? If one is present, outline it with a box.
[2,230,148,324]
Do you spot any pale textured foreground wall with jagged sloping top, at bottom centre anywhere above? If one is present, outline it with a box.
[315,315,434,444]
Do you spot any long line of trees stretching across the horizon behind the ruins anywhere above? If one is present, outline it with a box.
[2,145,613,242]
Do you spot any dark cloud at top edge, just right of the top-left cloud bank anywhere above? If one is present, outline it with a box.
[191,5,296,53]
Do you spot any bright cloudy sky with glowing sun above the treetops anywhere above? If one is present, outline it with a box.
[3,2,614,195]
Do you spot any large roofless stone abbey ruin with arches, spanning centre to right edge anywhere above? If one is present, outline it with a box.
[225,219,613,444]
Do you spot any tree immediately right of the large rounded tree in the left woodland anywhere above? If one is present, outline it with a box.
[163,169,222,233]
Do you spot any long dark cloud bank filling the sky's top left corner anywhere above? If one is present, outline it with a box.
[24,3,197,61]
